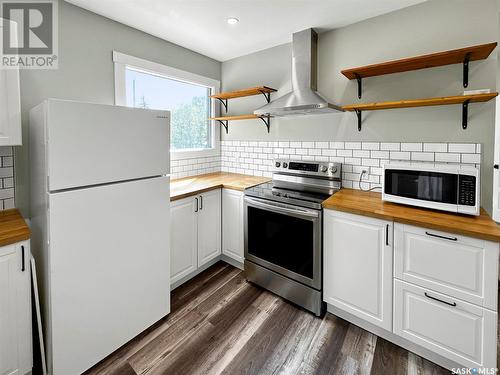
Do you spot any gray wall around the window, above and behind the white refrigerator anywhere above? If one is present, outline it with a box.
[15,1,221,216]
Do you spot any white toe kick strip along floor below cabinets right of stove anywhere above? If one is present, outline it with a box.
[327,304,465,370]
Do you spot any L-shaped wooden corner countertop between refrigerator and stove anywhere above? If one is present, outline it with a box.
[170,172,270,201]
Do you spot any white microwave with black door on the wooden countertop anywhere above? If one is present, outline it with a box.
[382,162,481,215]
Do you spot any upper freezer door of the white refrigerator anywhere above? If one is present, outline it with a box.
[46,99,170,191]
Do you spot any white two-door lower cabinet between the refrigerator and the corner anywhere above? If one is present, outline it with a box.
[170,189,221,284]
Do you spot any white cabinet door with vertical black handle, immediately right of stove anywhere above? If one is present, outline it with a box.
[323,210,393,331]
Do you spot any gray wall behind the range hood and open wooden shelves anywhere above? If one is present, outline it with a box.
[222,0,498,211]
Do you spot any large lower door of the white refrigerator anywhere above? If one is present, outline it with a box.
[49,177,170,375]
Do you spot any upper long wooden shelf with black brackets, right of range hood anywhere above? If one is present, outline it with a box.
[342,42,497,99]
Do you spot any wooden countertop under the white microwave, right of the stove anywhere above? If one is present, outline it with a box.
[323,189,500,242]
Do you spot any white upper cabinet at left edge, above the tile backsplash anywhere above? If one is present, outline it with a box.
[0,19,22,146]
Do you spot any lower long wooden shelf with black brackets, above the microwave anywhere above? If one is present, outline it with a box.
[342,92,498,131]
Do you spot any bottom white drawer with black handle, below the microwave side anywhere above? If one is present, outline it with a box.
[394,280,497,367]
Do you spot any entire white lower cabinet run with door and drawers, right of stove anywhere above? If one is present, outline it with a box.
[323,209,499,373]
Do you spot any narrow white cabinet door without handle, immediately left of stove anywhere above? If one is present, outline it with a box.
[222,189,244,263]
